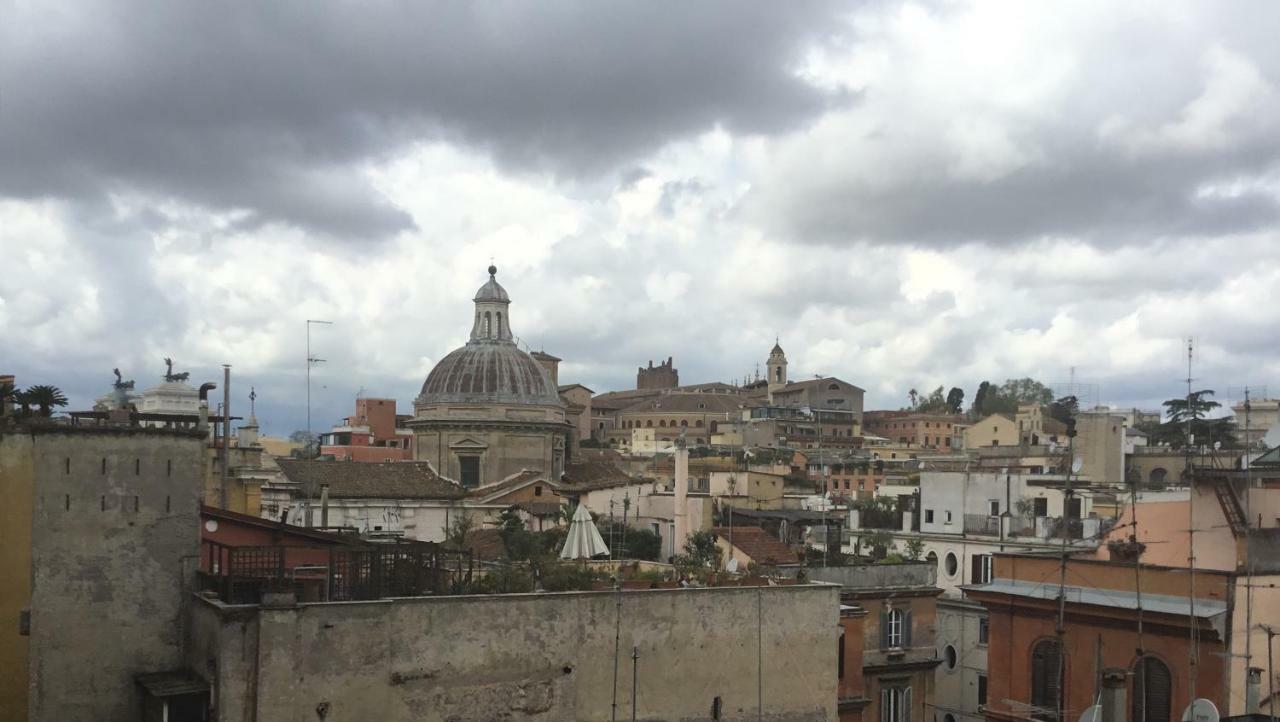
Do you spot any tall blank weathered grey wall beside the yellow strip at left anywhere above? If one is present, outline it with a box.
[29,430,204,722]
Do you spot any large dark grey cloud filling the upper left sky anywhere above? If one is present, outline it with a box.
[0,3,832,238]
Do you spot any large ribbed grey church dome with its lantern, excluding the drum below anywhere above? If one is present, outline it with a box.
[416,266,562,406]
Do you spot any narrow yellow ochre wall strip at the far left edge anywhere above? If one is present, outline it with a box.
[0,434,36,722]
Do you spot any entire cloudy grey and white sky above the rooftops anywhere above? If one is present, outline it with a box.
[0,0,1280,434]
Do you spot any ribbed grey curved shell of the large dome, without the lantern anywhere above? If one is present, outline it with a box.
[417,342,561,406]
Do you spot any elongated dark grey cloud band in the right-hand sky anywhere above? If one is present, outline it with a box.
[769,140,1280,246]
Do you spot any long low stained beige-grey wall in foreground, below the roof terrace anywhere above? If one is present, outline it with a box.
[189,585,840,722]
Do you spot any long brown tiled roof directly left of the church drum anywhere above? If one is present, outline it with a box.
[278,458,465,499]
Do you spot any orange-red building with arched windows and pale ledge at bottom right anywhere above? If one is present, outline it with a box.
[965,553,1235,722]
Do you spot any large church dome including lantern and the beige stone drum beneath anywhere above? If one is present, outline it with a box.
[408,266,576,488]
